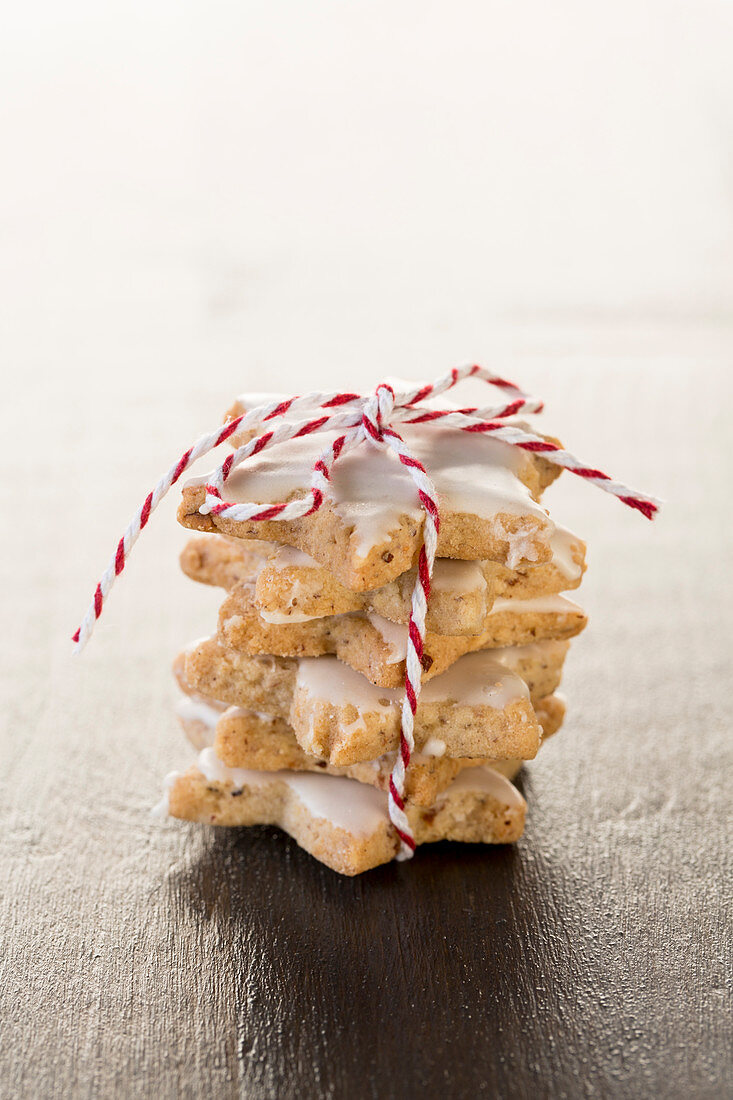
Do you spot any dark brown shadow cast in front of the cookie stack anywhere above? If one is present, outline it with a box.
[158,770,589,1097]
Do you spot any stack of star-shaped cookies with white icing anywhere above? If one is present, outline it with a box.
[157,395,586,875]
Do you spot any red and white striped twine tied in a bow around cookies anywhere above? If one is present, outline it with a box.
[74,365,659,859]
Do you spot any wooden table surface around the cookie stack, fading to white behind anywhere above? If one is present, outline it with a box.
[0,0,733,1100]
